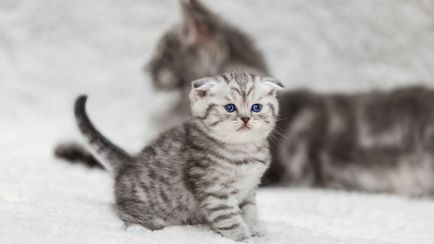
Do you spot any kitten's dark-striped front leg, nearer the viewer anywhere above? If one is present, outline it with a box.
[201,193,250,241]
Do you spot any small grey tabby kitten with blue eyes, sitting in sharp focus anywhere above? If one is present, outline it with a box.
[75,73,282,241]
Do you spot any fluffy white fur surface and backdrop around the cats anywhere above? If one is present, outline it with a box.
[0,0,434,244]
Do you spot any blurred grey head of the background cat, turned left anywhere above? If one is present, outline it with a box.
[146,0,268,90]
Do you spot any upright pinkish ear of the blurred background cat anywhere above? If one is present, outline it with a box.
[181,0,213,44]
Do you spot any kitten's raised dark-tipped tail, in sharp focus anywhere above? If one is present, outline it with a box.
[74,95,132,174]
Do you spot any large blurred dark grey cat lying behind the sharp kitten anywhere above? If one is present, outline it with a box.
[57,0,434,196]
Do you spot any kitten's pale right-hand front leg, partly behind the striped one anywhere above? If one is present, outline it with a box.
[239,189,264,236]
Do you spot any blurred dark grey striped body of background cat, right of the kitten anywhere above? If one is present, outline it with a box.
[265,86,434,196]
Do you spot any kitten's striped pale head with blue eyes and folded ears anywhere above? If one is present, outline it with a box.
[190,72,283,144]
